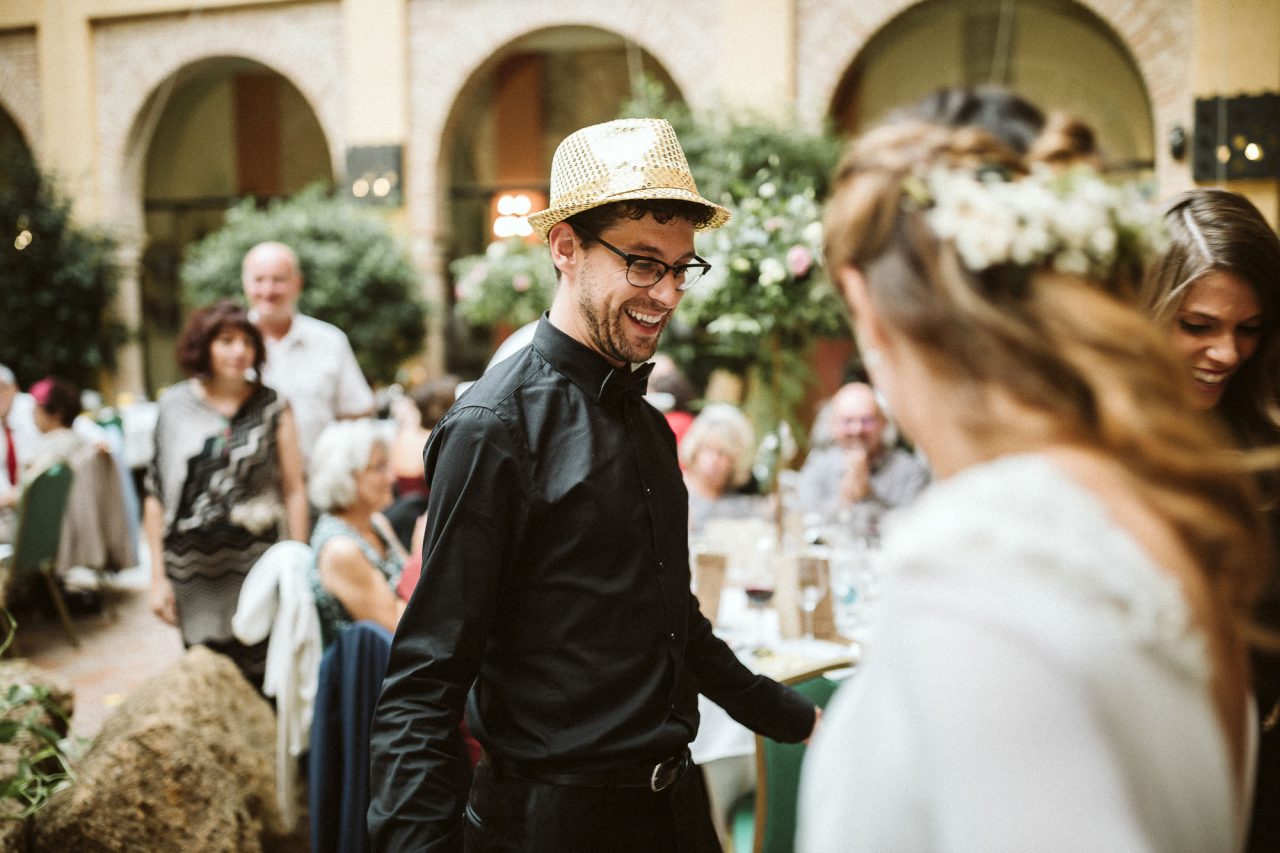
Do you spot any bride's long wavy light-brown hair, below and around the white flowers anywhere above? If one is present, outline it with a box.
[824,123,1270,778]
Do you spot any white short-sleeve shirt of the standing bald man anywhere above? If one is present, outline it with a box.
[262,314,374,460]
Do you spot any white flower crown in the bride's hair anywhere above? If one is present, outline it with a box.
[902,168,1165,282]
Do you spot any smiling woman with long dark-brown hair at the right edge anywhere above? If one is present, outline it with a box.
[1142,188,1280,850]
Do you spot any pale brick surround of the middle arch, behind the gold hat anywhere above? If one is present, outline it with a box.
[404,0,721,371]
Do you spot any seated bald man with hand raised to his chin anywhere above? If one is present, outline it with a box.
[796,382,929,528]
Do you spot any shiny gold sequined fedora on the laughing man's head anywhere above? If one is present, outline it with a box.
[529,119,730,240]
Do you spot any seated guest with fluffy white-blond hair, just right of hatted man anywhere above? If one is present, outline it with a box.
[680,403,765,535]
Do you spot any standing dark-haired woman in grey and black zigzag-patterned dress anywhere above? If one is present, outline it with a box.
[143,300,308,686]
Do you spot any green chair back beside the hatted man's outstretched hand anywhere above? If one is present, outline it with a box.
[753,661,851,853]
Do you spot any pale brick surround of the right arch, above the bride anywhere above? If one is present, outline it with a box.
[796,0,1194,192]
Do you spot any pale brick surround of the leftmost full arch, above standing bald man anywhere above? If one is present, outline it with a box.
[95,4,346,238]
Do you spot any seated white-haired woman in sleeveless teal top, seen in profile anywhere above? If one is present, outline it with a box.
[307,420,407,647]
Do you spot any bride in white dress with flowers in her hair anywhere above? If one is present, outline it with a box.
[800,124,1265,853]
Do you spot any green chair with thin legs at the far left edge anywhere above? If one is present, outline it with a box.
[6,465,79,646]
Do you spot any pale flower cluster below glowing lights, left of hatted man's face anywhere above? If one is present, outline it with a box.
[449,237,556,328]
